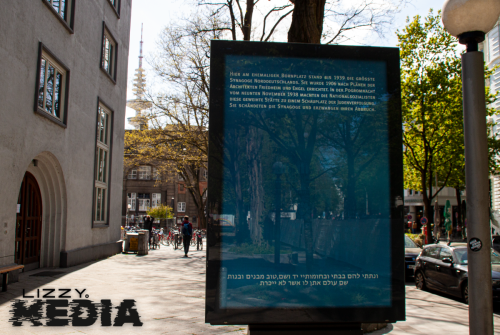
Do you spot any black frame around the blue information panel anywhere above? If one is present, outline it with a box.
[205,41,405,325]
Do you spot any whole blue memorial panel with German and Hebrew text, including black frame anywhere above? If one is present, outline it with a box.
[206,41,405,324]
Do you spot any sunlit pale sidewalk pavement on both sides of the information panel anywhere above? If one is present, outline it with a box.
[0,246,500,335]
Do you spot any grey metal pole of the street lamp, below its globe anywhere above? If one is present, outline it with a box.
[462,49,493,335]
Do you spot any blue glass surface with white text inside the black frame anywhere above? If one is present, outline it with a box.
[217,55,392,309]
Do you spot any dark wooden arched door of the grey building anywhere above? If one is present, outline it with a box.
[15,172,42,270]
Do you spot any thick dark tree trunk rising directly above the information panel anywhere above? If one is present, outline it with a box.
[288,0,326,44]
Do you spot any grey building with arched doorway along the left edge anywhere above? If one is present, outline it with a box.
[0,0,132,270]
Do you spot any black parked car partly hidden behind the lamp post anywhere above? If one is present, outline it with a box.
[415,243,500,303]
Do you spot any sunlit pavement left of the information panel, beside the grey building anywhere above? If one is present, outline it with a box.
[0,246,246,335]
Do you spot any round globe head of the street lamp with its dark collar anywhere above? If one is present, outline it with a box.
[442,0,500,51]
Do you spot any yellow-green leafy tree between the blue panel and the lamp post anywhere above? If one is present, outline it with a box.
[397,10,498,241]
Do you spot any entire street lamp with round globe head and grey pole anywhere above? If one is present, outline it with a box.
[443,0,500,335]
